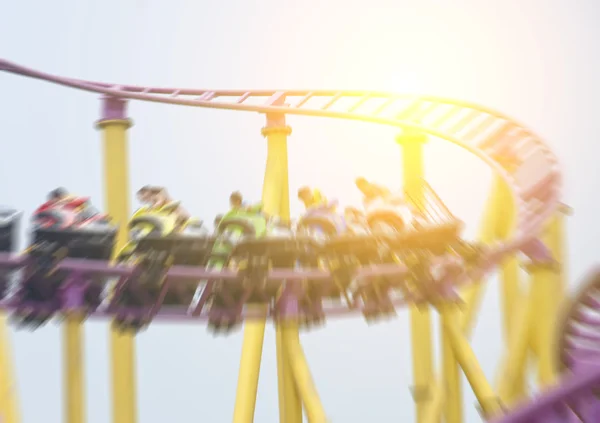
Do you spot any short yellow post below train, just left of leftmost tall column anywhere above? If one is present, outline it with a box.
[63,315,86,423]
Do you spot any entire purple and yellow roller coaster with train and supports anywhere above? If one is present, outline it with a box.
[0,60,600,423]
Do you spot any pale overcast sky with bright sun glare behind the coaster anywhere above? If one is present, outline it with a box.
[0,0,600,423]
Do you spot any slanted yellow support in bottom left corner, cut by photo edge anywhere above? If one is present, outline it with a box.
[0,315,21,423]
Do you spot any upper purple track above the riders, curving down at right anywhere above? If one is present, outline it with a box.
[0,60,561,276]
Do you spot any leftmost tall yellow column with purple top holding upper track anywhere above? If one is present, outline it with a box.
[97,97,137,423]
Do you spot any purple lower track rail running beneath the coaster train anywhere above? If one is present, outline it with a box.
[0,237,550,321]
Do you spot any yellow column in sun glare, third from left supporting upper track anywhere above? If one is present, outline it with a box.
[396,133,433,423]
